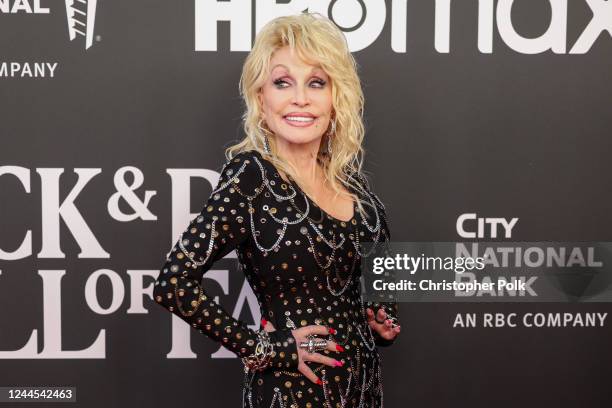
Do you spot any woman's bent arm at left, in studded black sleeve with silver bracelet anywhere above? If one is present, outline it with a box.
[153,152,297,369]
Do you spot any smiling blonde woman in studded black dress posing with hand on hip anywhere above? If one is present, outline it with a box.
[154,14,400,407]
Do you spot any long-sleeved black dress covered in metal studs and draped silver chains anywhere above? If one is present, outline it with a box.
[154,150,397,408]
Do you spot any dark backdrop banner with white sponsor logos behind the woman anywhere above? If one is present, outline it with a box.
[0,0,612,408]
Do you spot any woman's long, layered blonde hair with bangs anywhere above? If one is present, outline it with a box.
[225,13,372,217]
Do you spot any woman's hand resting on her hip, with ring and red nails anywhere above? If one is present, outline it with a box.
[262,320,344,385]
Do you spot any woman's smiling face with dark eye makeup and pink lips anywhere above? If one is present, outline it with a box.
[258,46,332,151]
